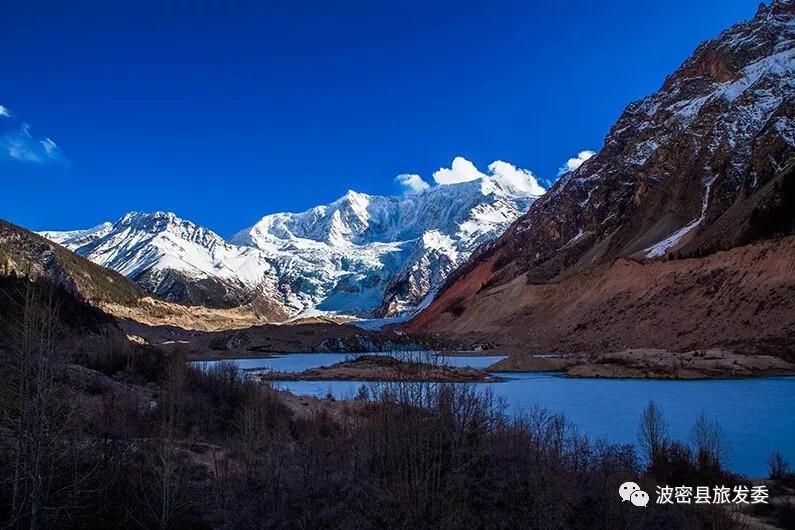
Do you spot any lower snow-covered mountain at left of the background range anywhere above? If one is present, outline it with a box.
[41,212,283,318]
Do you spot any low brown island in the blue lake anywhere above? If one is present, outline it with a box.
[253,355,502,383]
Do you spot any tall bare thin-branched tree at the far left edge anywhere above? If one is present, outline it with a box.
[2,281,82,529]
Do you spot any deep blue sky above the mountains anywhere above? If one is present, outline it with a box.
[0,0,758,235]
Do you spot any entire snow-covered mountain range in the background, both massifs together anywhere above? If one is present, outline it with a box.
[41,175,538,318]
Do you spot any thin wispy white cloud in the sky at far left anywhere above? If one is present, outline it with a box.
[0,105,66,164]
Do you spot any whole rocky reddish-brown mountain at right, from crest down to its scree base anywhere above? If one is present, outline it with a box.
[408,0,795,354]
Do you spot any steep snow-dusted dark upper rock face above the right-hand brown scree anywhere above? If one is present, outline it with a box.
[409,0,795,354]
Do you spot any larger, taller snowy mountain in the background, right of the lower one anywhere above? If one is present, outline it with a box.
[230,177,543,315]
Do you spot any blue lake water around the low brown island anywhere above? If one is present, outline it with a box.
[193,354,795,477]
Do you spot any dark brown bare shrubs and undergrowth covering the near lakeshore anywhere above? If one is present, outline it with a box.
[0,274,784,528]
